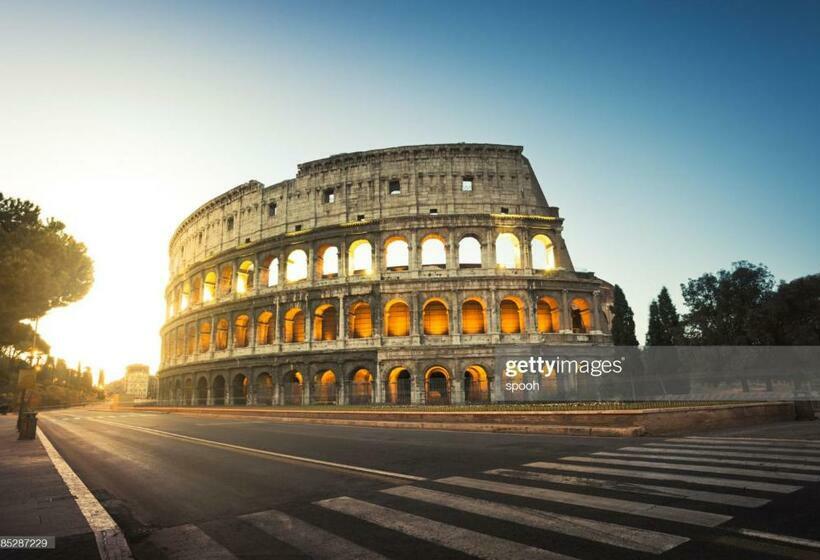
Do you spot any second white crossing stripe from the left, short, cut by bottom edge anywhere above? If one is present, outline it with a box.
[239,510,385,560]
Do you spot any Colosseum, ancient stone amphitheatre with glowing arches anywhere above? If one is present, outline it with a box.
[159,143,612,406]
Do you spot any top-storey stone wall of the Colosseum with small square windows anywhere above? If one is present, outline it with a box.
[169,144,558,277]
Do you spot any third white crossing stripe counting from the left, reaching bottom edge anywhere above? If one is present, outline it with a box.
[316,496,572,560]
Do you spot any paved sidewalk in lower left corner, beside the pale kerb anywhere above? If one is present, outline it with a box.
[0,414,99,559]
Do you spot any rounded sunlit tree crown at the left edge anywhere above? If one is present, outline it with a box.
[0,193,94,337]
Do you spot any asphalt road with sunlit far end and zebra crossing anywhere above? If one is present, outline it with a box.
[36,410,820,560]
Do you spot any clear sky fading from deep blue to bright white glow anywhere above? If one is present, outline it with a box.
[0,0,820,380]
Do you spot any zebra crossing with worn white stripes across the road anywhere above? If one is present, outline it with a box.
[135,437,820,560]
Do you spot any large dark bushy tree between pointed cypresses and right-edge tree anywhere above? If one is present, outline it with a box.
[681,261,774,346]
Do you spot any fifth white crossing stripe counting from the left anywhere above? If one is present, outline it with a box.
[436,476,732,527]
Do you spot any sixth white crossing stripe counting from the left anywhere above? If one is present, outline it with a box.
[484,469,769,508]
